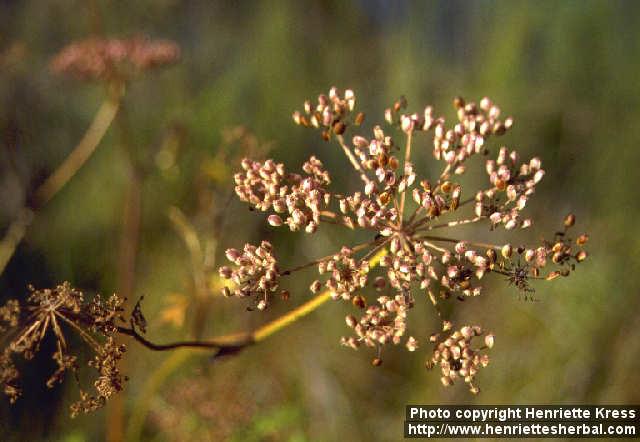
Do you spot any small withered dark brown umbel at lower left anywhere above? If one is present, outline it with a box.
[0,283,139,416]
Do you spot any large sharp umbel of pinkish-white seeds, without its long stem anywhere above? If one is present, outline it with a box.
[220,87,587,393]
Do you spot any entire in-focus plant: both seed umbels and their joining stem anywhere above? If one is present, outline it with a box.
[0,88,588,415]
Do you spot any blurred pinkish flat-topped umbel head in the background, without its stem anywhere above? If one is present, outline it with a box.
[51,37,180,80]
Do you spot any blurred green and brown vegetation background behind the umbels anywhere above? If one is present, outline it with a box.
[0,0,640,441]
